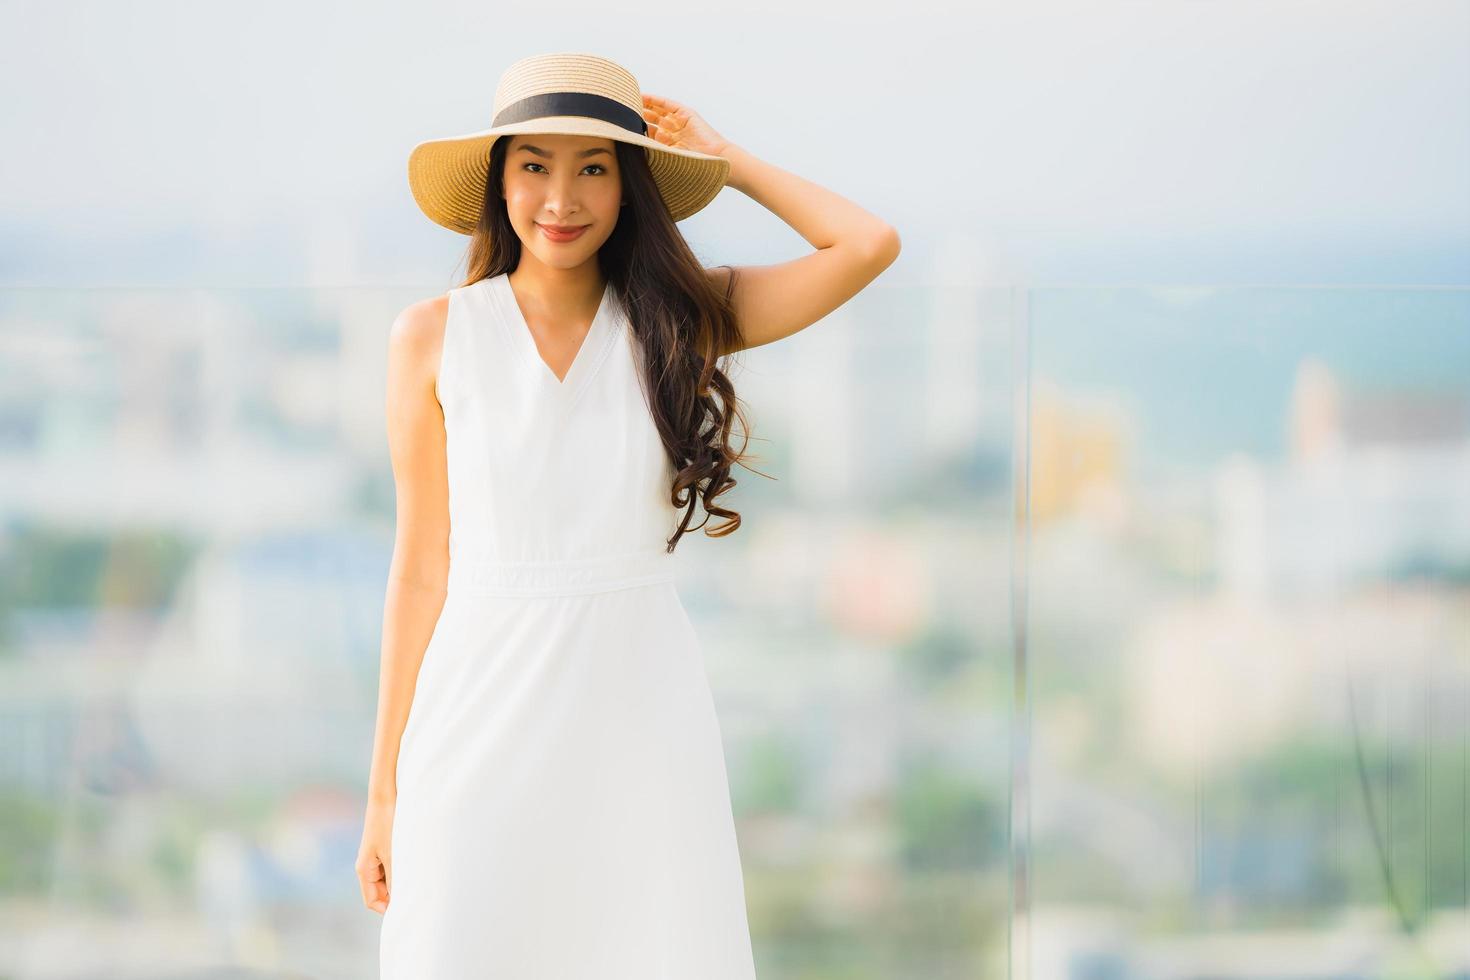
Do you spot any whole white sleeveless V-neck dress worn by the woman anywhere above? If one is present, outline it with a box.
[379,275,756,980]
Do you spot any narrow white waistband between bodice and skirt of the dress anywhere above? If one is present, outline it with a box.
[445,548,675,595]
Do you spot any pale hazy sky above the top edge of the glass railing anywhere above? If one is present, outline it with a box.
[0,0,1470,285]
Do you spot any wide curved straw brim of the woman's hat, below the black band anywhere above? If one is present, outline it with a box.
[409,116,731,235]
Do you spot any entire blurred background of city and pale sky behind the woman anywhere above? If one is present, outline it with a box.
[0,0,1470,980]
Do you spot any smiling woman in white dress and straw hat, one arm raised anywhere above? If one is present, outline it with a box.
[357,53,898,980]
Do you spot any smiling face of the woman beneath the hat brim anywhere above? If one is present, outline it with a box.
[504,134,623,269]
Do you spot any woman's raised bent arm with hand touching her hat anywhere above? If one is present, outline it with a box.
[644,94,901,354]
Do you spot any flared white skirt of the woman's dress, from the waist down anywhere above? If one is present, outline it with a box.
[379,560,756,980]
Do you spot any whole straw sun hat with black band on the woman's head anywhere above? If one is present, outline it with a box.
[409,51,731,235]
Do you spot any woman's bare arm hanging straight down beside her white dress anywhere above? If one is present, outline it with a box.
[357,297,450,912]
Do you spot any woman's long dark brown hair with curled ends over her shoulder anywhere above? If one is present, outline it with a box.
[462,138,764,552]
